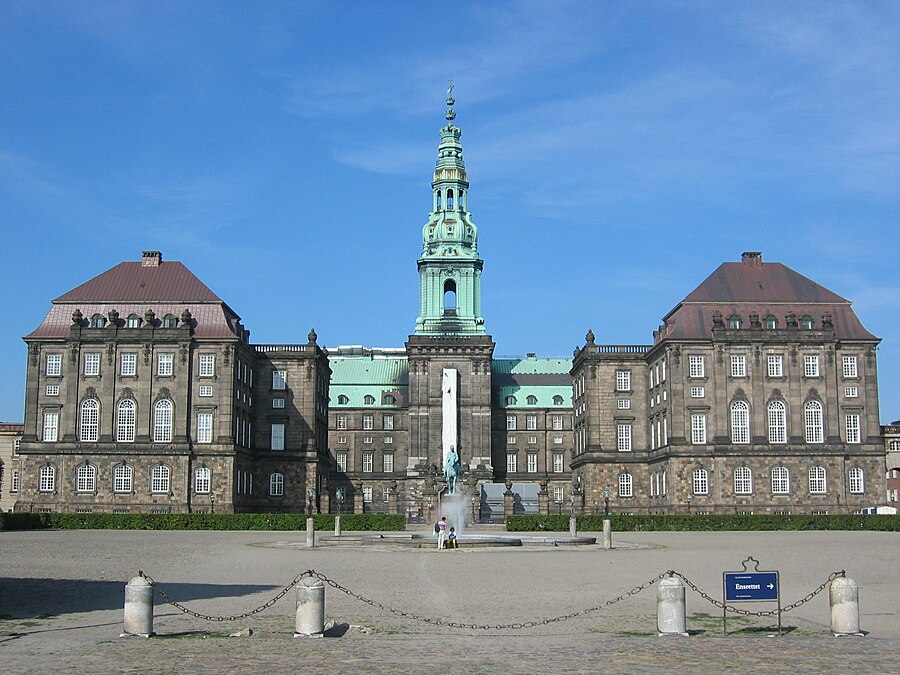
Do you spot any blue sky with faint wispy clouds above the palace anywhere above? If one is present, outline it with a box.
[0,0,900,422]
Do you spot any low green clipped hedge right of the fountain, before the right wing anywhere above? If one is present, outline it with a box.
[506,514,900,532]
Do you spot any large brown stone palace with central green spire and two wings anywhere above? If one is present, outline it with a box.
[13,98,885,520]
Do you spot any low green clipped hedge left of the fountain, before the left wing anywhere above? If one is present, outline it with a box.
[0,513,406,531]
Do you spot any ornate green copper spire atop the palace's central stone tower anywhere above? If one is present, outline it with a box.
[416,86,484,335]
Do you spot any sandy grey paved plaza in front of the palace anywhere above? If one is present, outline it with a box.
[0,531,900,673]
